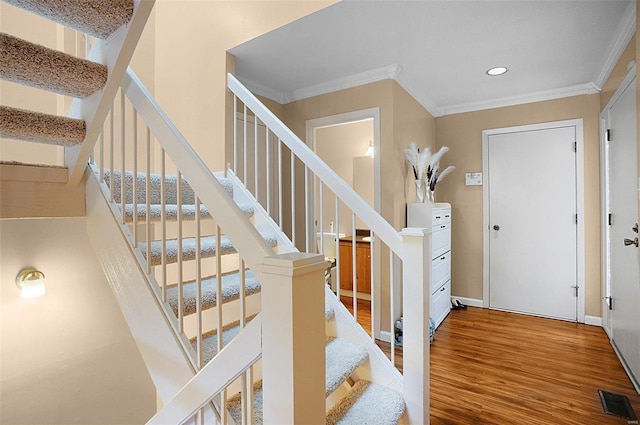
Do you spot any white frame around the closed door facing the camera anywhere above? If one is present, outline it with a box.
[482,118,586,323]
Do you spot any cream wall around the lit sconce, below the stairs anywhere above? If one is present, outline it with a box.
[0,218,156,425]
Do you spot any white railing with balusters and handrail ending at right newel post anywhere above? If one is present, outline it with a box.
[227,74,431,423]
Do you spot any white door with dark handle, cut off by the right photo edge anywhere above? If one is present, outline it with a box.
[604,70,640,391]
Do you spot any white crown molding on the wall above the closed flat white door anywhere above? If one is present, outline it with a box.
[440,83,600,115]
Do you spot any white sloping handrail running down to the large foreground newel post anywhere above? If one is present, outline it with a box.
[121,68,273,270]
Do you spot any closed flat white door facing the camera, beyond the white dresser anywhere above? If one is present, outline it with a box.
[485,125,581,321]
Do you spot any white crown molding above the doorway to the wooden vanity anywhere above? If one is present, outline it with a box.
[284,64,401,103]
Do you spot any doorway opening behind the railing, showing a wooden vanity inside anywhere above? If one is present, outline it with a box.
[306,108,380,336]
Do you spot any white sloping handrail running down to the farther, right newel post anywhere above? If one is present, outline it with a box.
[227,73,403,258]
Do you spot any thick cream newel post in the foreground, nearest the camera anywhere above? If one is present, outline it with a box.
[259,253,328,425]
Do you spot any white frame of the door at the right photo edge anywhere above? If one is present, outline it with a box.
[600,63,638,339]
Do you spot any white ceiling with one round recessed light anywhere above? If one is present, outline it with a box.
[230,0,636,116]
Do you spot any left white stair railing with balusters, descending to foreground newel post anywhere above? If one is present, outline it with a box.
[90,69,298,424]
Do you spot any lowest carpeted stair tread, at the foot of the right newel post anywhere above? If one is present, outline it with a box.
[326,380,405,425]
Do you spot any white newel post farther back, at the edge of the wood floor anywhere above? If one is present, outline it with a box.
[400,227,431,424]
